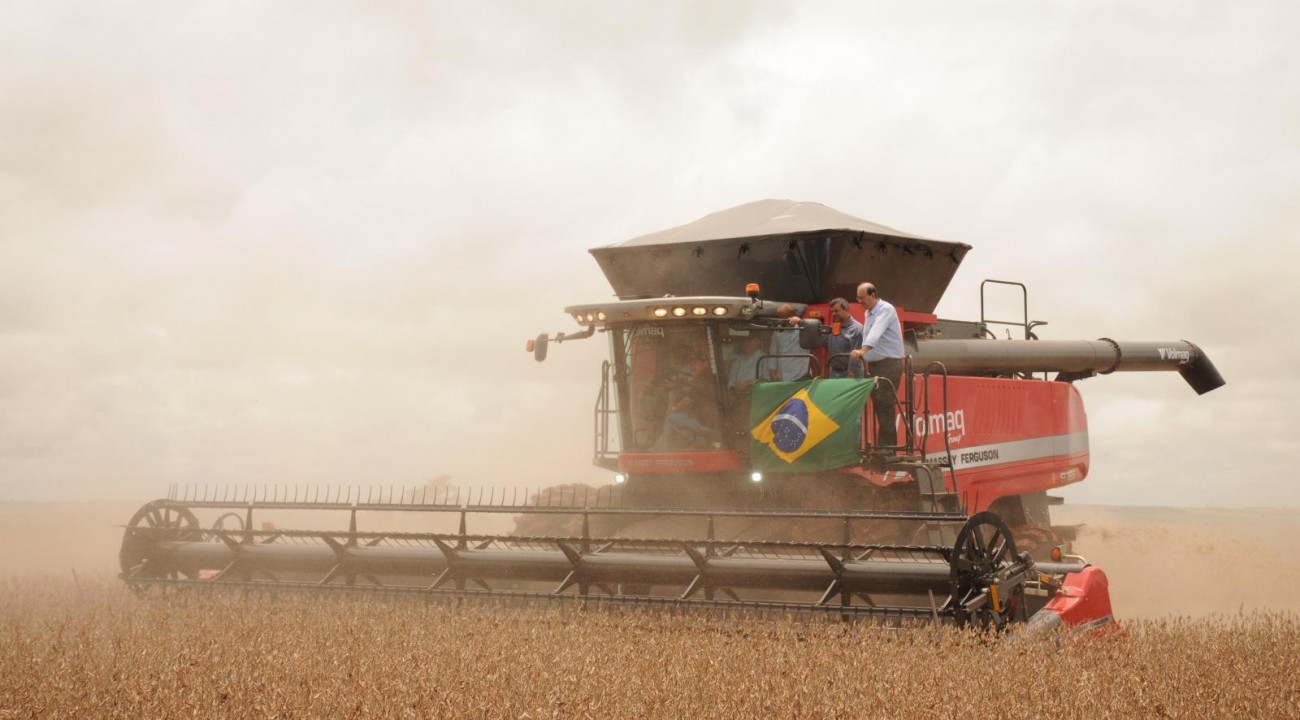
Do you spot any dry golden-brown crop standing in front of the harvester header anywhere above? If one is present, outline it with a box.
[0,578,1300,719]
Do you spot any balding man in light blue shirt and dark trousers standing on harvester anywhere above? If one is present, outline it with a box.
[853,282,904,447]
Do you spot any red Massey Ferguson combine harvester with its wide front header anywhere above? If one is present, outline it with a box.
[121,200,1223,628]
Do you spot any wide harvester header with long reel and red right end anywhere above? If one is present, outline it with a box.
[121,489,1110,629]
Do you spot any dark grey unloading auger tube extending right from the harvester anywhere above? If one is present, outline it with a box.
[909,338,1225,395]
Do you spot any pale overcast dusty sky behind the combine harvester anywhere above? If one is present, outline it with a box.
[0,0,1300,506]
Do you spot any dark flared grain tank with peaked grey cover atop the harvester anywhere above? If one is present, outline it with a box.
[592,200,970,312]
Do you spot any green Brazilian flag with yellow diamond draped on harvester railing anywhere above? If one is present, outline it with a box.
[749,378,876,473]
